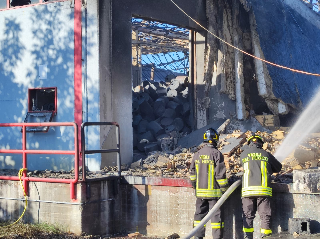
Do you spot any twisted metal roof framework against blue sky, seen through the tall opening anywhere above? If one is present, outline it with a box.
[132,18,189,78]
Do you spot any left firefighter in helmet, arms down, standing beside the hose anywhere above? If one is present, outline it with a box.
[190,128,228,239]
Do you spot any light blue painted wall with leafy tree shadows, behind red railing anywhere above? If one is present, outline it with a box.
[0,1,99,170]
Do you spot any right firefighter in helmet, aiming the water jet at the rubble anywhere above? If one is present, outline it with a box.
[240,134,282,239]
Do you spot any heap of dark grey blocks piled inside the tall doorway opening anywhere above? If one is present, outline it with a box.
[132,76,191,154]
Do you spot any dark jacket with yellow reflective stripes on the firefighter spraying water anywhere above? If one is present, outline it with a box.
[240,143,282,197]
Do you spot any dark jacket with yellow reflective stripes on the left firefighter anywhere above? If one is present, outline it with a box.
[190,144,228,199]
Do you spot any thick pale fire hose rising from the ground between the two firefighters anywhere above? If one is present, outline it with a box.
[183,180,241,239]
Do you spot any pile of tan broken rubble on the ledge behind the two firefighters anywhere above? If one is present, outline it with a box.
[117,130,320,183]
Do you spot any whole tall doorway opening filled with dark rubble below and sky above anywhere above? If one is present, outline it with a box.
[132,17,192,155]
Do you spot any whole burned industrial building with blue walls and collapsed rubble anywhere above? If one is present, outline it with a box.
[0,0,320,238]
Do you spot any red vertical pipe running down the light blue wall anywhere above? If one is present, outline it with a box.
[74,0,82,165]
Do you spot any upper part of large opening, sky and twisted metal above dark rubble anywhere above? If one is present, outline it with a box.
[132,18,189,87]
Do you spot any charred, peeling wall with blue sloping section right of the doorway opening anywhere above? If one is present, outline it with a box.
[198,0,320,126]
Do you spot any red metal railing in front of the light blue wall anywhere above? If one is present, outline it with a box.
[0,122,79,199]
